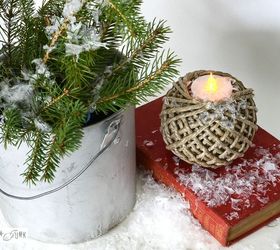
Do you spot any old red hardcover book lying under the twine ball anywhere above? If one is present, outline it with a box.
[136,98,280,246]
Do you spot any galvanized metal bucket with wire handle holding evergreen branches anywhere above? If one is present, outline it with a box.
[0,108,136,243]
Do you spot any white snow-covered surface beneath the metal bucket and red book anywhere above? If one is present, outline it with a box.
[0,171,280,250]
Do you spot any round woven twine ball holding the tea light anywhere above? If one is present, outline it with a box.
[160,70,258,168]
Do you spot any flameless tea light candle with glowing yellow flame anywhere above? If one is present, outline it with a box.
[191,73,233,102]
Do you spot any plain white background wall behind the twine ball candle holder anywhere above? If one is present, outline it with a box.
[143,0,280,138]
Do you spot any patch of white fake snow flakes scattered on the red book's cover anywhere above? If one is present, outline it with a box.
[175,146,280,211]
